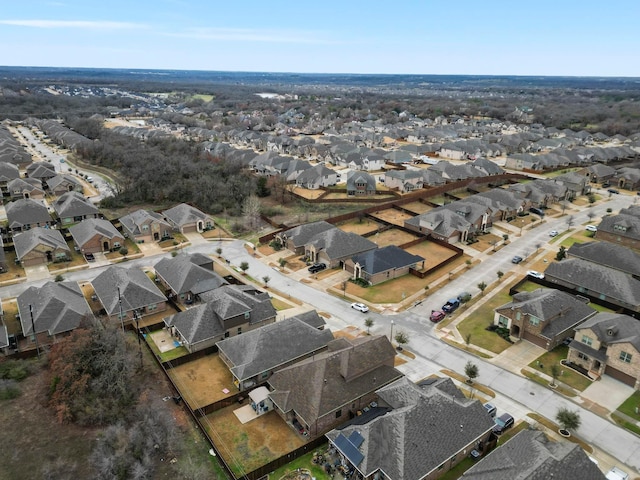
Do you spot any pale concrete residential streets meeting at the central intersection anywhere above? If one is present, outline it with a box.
[0,190,640,471]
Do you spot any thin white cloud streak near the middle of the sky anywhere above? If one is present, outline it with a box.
[167,28,339,44]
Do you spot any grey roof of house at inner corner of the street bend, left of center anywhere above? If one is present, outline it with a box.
[155,255,228,295]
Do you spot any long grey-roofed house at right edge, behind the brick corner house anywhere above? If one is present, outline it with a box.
[544,258,640,312]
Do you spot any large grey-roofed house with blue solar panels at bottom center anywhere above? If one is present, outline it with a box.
[326,377,494,480]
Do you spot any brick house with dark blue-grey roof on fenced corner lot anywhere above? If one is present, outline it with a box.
[344,245,424,285]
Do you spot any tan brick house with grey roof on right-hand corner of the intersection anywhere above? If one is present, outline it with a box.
[493,288,596,351]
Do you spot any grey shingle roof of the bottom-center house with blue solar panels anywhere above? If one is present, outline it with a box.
[327,377,494,480]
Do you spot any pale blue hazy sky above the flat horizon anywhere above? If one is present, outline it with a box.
[0,0,640,77]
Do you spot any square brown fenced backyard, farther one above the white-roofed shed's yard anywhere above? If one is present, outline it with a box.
[169,354,238,409]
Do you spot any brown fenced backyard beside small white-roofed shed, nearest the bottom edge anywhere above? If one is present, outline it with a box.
[204,405,307,477]
